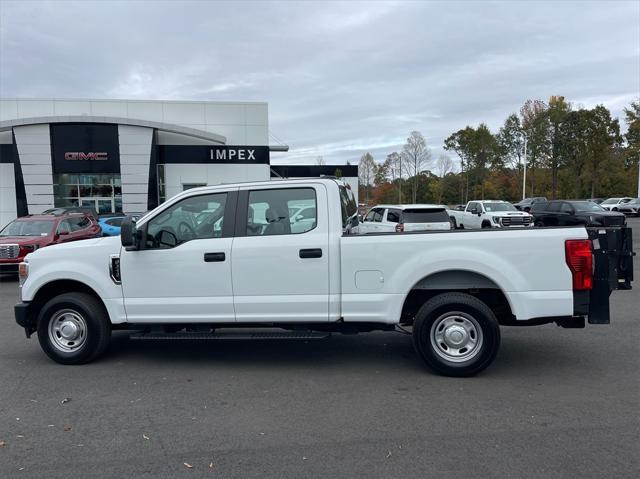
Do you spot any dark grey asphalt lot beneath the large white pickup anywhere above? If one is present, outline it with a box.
[0,219,640,479]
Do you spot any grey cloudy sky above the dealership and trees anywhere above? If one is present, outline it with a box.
[0,0,640,164]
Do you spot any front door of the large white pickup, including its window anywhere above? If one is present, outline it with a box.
[120,191,237,323]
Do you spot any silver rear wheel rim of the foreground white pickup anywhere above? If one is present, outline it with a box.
[430,312,483,363]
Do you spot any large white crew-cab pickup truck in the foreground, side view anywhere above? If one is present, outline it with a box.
[15,179,632,376]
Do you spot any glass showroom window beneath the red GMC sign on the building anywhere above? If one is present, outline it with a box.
[53,173,122,213]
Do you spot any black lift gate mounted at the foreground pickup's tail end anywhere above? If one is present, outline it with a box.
[587,227,635,324]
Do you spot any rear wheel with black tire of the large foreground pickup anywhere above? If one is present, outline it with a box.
[413,293,500,377]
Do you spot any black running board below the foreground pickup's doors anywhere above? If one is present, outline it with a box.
[129,331,331,341]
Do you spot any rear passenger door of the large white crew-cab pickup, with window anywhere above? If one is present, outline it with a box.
[231,183,329,322]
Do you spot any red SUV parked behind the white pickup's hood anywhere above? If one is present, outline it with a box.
[0,213,102,273]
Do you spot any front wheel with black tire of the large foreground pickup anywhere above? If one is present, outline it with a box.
[38,293,111,364]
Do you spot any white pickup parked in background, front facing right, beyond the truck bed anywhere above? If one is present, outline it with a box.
[449,200,533,229]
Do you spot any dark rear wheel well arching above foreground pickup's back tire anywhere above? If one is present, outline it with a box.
[400,270,515,324]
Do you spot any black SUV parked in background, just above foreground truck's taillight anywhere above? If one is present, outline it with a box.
[531,200,626,226]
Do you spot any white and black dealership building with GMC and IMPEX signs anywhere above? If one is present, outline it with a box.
[0,99,358,228]
